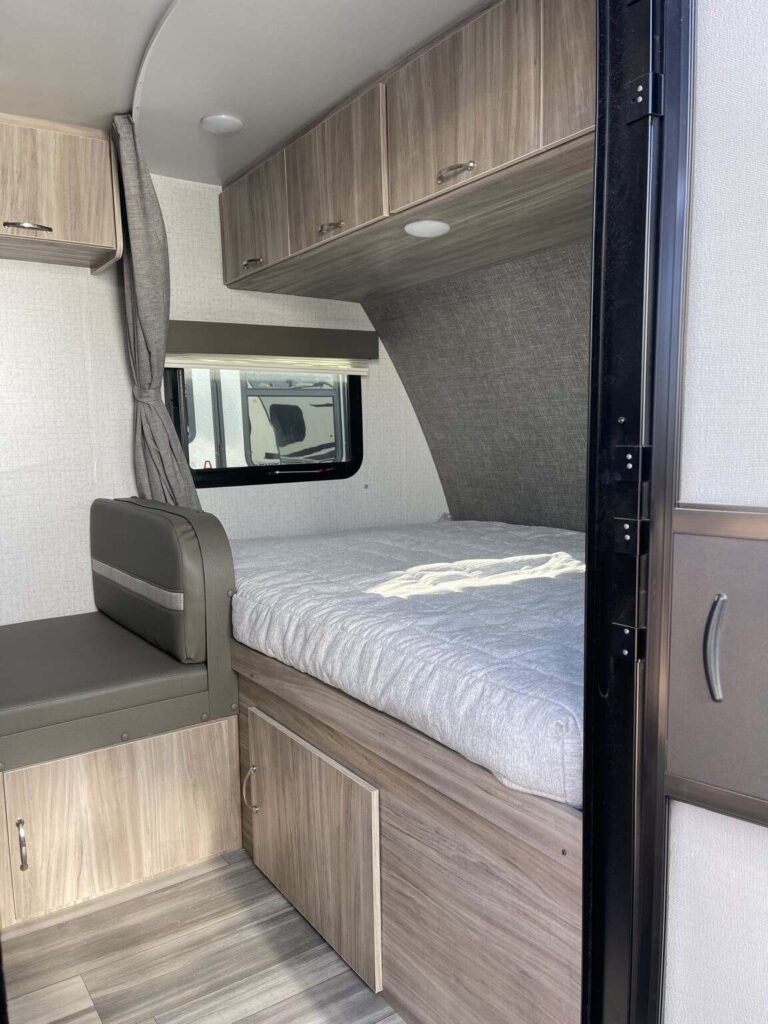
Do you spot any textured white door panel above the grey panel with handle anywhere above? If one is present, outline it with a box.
[681,0,768,506]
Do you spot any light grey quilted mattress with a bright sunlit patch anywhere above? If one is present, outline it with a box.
[232,521,585,807]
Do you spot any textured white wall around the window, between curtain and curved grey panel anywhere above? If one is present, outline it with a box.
[154,175,447,538]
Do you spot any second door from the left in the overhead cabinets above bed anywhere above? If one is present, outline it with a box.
[286,85,387,253]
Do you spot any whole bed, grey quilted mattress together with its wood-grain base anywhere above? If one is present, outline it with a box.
[232,521,585,1024]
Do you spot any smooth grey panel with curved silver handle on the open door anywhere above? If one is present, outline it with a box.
[667,535,768,800]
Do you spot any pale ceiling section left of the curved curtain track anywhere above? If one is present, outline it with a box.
[0,0,171,128]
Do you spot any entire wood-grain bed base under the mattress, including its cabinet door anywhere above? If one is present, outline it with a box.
[232,643,582,1024]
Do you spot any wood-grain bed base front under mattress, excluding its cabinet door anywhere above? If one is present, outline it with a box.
[232,642,582,1024]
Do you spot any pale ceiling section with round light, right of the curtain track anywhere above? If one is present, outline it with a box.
[131,0,487,183]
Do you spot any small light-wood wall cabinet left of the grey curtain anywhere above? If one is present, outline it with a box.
[0,115,122,270]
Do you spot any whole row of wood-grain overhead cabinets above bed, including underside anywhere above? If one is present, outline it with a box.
[221,0,595,300]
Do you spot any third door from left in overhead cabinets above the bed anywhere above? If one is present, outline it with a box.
[387,0,541,210]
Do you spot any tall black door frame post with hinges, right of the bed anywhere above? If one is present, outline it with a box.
[583,0,667,1024]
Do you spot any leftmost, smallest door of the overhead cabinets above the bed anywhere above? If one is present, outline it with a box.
[220,151,289,284]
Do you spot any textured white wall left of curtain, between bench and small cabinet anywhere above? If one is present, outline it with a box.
[0,260,136,623]
